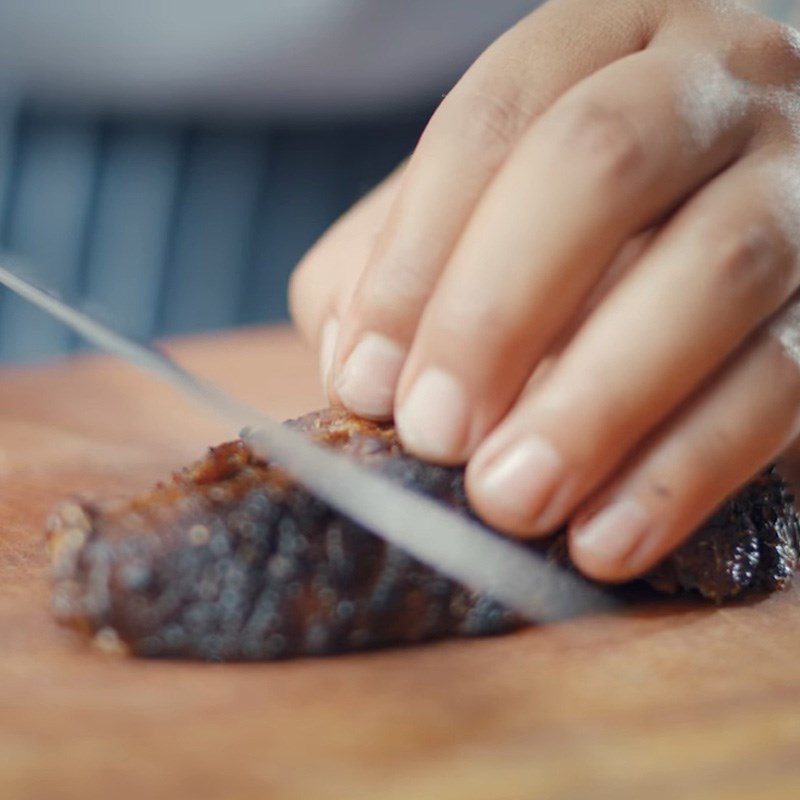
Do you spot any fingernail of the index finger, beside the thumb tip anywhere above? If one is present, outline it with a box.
[336,333,405,418]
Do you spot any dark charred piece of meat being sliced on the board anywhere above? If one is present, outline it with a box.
[48,410,800,660]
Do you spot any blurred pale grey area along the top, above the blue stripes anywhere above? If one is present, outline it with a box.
[0,0,537,118]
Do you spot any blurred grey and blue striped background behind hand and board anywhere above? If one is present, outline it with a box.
[0,0,798,363]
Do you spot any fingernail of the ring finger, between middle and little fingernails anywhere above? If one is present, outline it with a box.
[476,436,564,520]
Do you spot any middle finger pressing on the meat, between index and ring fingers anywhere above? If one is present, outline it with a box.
[397,45,752,462]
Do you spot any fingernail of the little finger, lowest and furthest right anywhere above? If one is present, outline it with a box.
[573,500,650,567]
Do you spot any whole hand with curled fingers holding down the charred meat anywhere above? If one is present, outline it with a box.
[290,0,800,581]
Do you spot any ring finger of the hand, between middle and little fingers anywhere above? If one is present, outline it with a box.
[470,153,800,533]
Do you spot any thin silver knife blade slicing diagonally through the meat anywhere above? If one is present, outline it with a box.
[0,266,617,622]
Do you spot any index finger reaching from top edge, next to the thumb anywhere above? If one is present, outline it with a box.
[328,0,657,417]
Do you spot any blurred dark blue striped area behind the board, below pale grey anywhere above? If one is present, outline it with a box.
[0,108,431,361]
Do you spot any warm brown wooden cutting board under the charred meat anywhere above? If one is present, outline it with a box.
[0,329,800,800]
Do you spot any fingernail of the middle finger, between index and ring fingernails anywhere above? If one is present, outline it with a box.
[397,367,469,461]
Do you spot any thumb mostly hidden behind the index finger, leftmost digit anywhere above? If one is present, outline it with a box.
[289,163,405,397]
